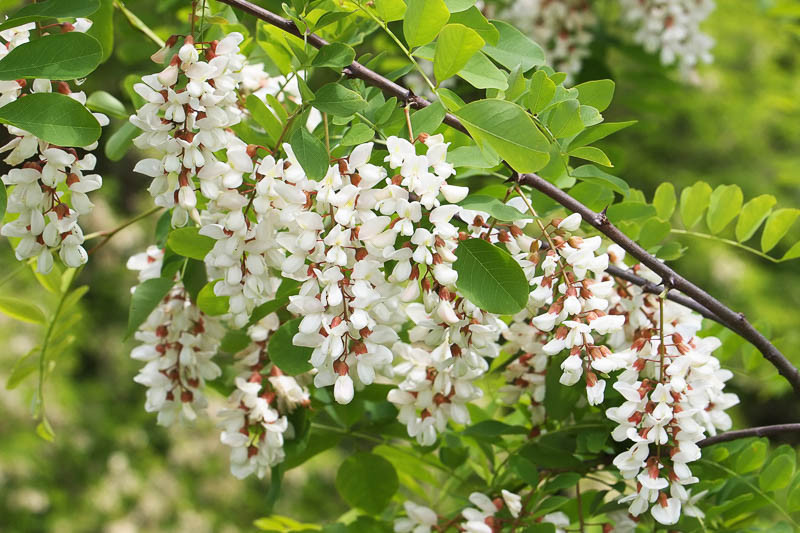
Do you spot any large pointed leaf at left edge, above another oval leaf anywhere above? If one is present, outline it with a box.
[0,31,103,80]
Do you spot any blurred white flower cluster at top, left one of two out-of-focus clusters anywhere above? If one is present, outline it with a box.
[500,0,597,78]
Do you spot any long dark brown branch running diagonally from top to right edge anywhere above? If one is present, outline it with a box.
[219,0,800,395]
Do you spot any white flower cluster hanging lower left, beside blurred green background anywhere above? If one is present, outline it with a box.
[128,246,224,426]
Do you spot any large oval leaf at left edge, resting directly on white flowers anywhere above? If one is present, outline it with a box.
[0,93,100,147]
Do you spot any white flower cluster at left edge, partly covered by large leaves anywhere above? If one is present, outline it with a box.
[0,18,108,274]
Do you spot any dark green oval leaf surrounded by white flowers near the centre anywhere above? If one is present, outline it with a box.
[453,239,529,315]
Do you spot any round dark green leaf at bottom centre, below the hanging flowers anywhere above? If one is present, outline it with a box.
[336,452,399,515]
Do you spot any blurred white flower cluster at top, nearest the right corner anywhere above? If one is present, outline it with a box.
[620,0,714,72]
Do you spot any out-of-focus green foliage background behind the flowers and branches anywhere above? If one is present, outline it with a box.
[0,0,800,533]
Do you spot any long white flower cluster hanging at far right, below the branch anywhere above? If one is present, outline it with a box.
[606,268,739,524]
